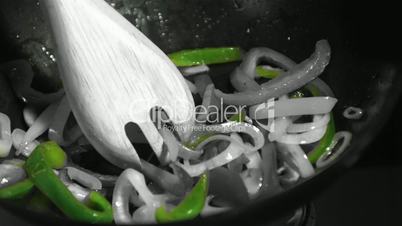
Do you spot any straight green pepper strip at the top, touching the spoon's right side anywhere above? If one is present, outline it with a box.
[168,47,241,67]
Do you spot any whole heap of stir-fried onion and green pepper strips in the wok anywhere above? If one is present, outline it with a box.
[0,40,351,224]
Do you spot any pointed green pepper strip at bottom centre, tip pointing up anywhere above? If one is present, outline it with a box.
[155,174,208,223]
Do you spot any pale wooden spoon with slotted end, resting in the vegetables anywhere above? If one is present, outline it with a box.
[40,0,194,168]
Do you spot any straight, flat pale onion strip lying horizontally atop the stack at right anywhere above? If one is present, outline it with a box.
[249,97,338,120]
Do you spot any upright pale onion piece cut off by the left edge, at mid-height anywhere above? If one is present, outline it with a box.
[0,112,13,158]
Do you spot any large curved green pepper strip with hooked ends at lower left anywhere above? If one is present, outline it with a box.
[25,142,113,223]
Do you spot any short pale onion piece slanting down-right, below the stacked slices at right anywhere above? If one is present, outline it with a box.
[277,143,314,178]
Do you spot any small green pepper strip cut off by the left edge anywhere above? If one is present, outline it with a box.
[0,179,34,200]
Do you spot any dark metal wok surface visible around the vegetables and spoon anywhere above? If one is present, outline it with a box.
[0,0,401,225]
